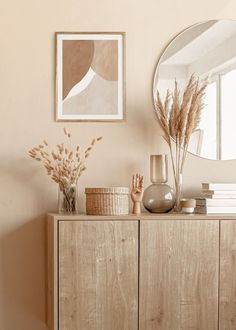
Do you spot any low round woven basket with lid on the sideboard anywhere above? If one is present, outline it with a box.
[85,187,129,215]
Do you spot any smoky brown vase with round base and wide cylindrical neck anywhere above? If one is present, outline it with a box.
[143,155,175,213]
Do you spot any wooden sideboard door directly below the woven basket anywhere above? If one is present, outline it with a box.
[58,221,138,330]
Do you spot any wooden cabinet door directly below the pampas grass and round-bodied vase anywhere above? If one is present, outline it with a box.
[139,220,219,330]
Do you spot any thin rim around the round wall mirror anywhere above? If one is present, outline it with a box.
[152,19,236,162]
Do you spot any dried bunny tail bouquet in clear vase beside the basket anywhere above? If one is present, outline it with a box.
[29,128,102,212]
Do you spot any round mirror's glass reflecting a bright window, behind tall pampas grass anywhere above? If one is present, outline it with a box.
[153,20,236,160]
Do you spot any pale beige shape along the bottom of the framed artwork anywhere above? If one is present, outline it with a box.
[63,75,118,115]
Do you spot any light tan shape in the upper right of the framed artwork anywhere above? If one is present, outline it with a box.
[92,40,118,81]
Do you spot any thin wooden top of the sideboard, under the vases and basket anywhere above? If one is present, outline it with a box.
[48,213,236,221]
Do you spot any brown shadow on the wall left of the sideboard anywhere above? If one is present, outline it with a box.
[0,215,47,330]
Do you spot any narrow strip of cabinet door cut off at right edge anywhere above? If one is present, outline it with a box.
[219,221,236,330]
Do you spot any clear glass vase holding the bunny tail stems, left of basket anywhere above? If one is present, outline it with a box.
[58,184,78,214]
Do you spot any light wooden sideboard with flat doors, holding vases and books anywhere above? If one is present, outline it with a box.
[47,214,236,330]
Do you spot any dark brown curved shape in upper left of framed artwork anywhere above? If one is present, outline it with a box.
[63,40,94,99]
